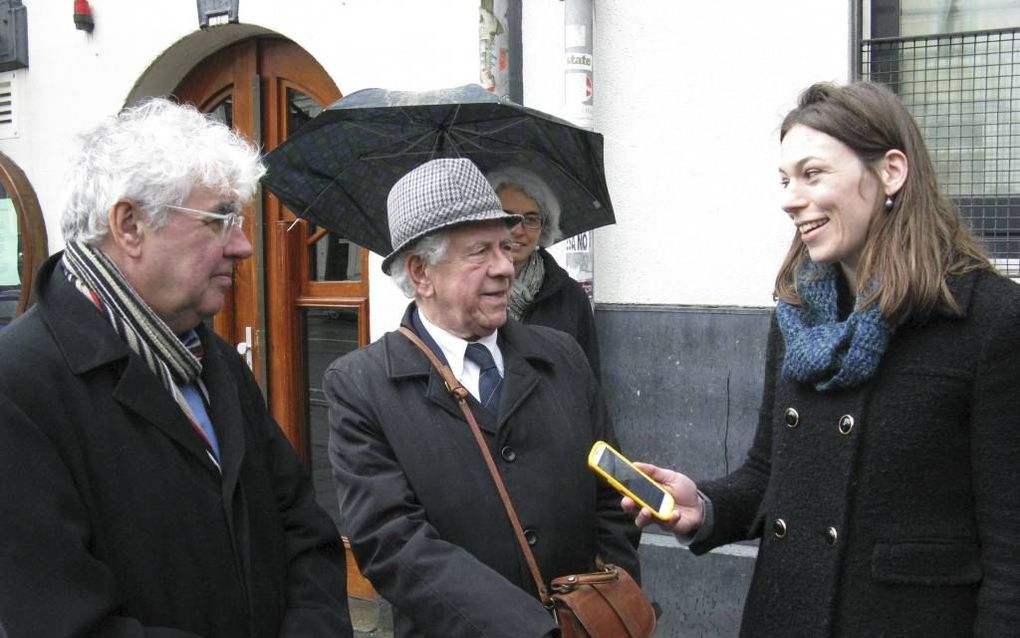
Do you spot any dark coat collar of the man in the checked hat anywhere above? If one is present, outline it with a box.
[383,303,554,433]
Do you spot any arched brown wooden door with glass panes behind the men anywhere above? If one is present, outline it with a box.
[173,37,368,567]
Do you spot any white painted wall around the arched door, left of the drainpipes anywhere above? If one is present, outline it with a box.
[0,0,478,337]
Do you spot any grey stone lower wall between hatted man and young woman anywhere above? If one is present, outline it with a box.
[596,305,770,638]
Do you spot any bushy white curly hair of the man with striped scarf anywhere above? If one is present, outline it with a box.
[60,98,265,245]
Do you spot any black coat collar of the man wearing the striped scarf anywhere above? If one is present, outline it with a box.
[36,252,229,476]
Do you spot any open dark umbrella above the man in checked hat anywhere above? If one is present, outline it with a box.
[262,85,615,255]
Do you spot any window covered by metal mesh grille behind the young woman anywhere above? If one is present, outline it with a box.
[856,0,1020,277]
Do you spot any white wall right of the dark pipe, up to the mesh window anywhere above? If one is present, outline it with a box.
[523,0,850,306]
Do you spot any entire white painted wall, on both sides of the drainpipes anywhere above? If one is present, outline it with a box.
[0,0,850,338]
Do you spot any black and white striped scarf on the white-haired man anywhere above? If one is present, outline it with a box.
[61,242,218,459]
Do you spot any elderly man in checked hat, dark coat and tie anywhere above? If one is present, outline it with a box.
[324,159,640,638]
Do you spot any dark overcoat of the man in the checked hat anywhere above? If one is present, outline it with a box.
[324,304,640,638]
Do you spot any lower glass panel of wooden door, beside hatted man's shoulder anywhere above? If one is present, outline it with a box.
[301,308,359,522]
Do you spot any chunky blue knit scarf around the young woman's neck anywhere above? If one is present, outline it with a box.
[776,261,893,392]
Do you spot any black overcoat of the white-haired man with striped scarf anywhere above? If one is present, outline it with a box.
[0,256,351,638]
